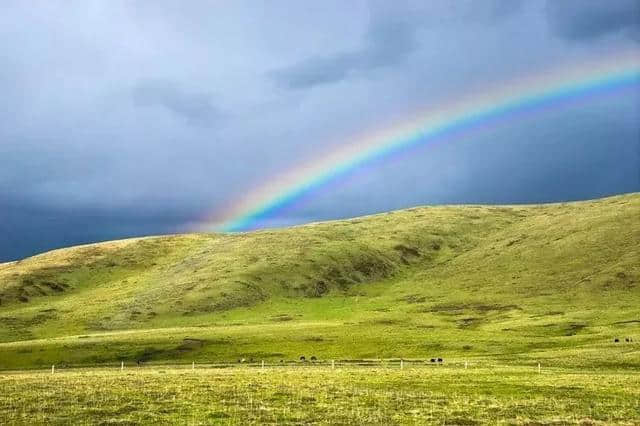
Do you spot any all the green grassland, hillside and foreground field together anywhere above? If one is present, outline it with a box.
[0,194,640,424]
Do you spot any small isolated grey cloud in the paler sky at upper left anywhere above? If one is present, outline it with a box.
[133,80,221,126]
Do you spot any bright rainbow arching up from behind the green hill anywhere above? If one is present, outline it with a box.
[204,51,640,232]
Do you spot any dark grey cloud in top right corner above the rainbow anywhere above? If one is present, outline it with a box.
[546,0,640,41]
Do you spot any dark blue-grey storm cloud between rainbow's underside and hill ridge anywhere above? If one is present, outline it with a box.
[296,96,640,223]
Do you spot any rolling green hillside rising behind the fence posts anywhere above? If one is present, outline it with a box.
[0,194,640,368]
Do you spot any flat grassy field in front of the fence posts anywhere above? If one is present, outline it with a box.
[0,364,640,425]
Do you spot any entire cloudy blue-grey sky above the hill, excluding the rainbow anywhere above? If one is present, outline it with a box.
[0,0,640,262]
